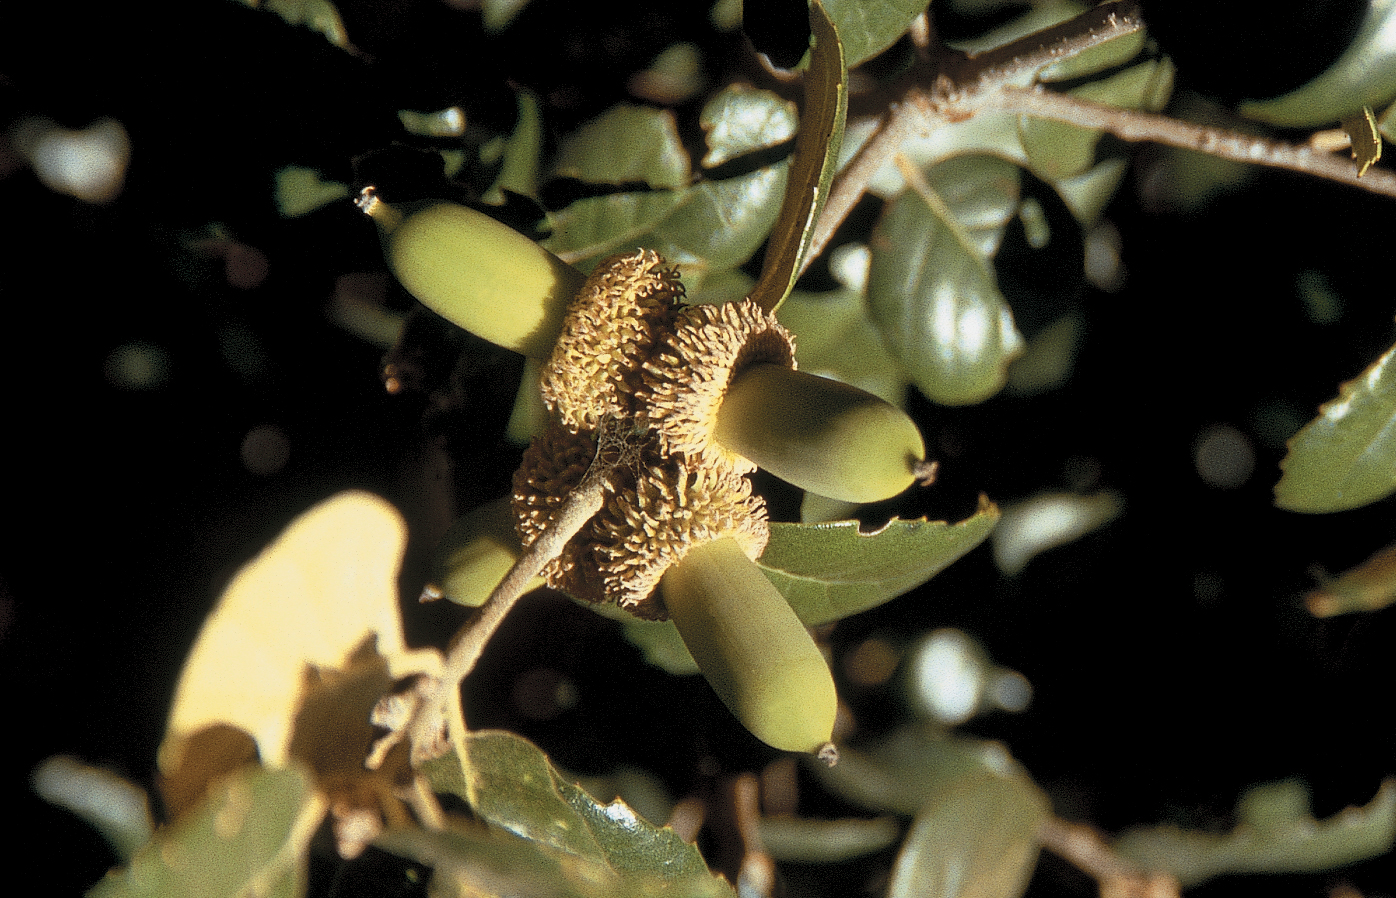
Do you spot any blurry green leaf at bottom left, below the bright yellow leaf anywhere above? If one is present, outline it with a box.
[88,768,314,898]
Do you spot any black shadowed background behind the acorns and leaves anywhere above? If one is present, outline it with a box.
[0,0,1396,895]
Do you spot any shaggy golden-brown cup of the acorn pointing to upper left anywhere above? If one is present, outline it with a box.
[540,250,684,433]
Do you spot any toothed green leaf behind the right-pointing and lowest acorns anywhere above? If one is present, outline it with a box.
[757,497,998,627]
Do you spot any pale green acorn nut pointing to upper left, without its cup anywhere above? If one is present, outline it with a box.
[356,187,585,359]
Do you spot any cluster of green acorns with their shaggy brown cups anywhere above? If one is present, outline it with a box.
[360,189,926,763]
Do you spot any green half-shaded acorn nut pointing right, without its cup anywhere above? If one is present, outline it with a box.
[713,365,926,503]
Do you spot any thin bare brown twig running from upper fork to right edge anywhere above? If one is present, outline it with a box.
[991,87,1396,197]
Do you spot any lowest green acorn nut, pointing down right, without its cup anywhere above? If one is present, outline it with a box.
[659,538,839,764]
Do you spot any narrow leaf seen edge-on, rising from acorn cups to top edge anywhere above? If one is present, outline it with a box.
[751,0,849,310]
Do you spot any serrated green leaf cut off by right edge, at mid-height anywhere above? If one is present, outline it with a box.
[1275,339,1396,513]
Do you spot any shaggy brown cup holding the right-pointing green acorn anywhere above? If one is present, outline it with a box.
[638,299,796,475]
